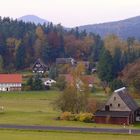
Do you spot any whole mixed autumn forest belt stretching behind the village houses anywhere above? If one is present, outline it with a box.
[0,18,140,76]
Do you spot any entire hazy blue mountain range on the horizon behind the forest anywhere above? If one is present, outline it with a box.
[18,15,140,39]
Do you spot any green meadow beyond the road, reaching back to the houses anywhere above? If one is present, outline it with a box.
[0,91,140,128]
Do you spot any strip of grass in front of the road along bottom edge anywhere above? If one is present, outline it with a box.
[0,130,140,140]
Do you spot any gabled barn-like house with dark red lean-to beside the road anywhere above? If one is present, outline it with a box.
[95,87,140,125]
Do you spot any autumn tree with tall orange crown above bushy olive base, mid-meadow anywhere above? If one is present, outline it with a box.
[54,63,89,113]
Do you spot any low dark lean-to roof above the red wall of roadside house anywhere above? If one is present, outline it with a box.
[95,111,130,117]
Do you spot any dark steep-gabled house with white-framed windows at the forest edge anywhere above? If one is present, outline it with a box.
[32,58,48,74]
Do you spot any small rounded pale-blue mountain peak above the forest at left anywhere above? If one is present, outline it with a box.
[18,15,49,25]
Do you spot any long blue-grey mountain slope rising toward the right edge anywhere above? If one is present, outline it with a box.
[79,16,140,39]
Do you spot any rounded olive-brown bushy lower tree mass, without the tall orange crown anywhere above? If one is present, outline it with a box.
[56,86,88,113]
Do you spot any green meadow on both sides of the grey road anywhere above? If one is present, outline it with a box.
[0,91,140,140]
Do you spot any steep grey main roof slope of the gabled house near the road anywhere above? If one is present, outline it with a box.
[114,89,139,111]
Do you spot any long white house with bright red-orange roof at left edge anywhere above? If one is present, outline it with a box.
[0,74,22,91]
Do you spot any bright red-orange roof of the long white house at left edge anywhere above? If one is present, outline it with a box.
[0,74,22,83]
